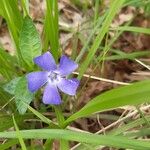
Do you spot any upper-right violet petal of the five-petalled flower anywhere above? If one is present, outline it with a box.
[58,55,78,76]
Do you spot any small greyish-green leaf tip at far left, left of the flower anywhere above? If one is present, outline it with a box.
[3,77,21,95]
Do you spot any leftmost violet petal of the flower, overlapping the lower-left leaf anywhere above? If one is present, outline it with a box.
[26,71,48,92]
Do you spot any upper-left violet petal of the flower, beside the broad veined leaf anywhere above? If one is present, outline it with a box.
[34,52,57,71]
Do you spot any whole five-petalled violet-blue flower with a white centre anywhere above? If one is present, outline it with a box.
[27,52,79,105]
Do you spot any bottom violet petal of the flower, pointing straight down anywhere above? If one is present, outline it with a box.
[43,84,61,105]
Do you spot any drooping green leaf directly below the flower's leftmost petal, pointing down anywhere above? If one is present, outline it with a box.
[15,77,34,114]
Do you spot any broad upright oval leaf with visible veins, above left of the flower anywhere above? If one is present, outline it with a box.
[19,17,42,69]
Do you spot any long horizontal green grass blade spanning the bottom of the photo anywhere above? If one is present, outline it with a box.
[0,129,150,150]
